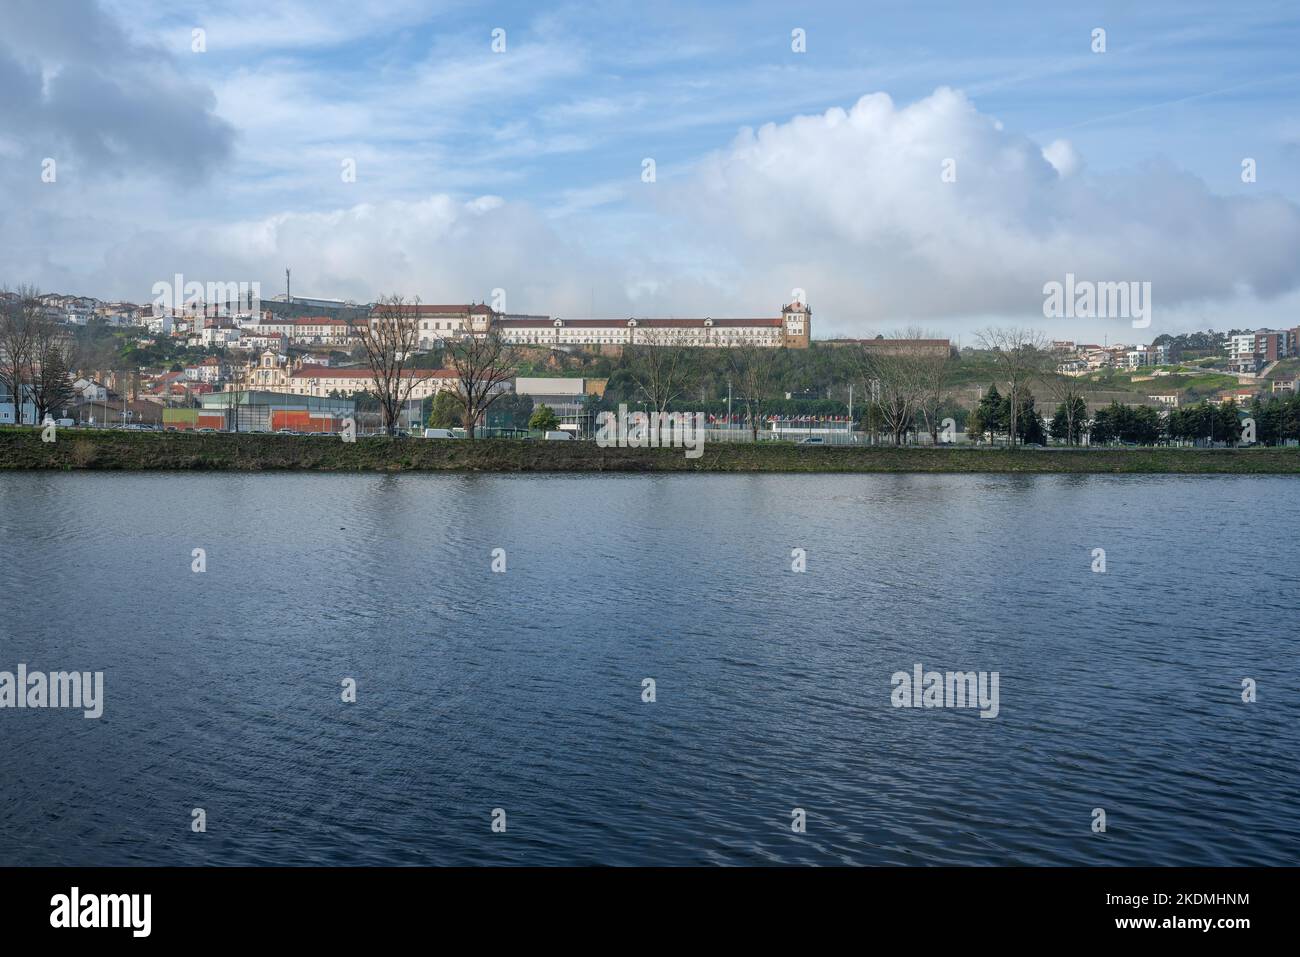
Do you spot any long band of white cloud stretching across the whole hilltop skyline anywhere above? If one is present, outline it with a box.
[10,78,1300,338]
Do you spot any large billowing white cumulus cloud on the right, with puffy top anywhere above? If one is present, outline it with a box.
[647,88,1300,329]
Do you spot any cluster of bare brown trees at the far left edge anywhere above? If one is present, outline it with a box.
[0,286,75,425]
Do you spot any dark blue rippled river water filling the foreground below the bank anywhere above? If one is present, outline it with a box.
[0,475,1300,865]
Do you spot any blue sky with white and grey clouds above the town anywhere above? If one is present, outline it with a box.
[0,0,1300,343]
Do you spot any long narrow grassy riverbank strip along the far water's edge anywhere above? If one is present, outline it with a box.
[0,428,1300,475]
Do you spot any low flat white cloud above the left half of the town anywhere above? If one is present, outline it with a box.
[85,194,616,312]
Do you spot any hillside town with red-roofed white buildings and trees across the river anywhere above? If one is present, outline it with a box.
[0,289,1300,445]
